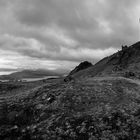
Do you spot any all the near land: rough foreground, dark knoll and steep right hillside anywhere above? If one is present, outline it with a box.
[0,42,140,140]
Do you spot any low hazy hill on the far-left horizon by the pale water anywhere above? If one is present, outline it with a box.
[0,69,62,80]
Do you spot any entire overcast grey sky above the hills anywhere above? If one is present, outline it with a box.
[0,0,140,73]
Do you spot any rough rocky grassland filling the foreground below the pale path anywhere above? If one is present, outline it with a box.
[0,77,140,140]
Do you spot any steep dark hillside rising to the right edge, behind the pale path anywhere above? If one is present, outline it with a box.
[65,42,140,78]
